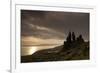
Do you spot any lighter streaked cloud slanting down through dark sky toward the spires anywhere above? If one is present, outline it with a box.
[21,24,65,39]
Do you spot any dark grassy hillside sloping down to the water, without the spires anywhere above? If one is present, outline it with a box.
[21,42,89,63]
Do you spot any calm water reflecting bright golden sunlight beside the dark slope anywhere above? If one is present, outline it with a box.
[21,45,57,56]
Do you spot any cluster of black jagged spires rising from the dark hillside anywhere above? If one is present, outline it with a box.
[62,32,84,51]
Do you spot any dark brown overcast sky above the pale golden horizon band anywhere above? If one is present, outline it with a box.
[21,10,89,45]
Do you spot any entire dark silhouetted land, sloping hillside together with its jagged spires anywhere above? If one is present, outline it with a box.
[21,32,89,63]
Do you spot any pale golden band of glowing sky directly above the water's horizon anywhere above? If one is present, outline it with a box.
[21,36,64,46]
